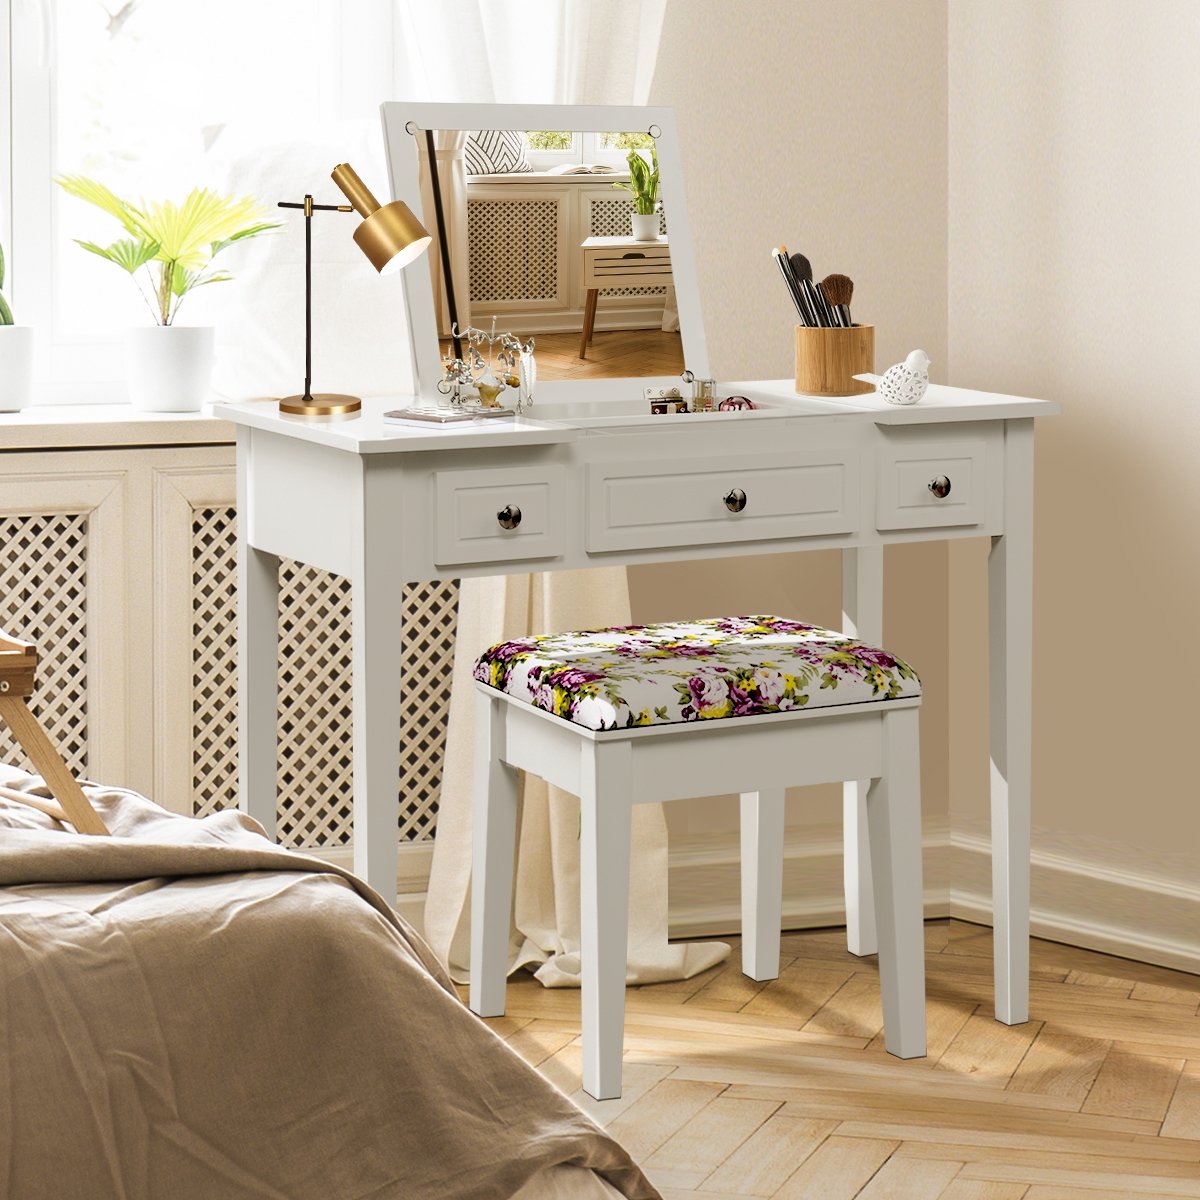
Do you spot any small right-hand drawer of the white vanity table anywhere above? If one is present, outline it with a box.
[875,439,988,529]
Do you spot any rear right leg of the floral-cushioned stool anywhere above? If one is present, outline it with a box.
[742,787,785,979]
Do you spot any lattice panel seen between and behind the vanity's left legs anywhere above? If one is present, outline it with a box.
[192,508,458,847]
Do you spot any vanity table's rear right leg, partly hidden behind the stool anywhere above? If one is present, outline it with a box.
[841,546,883,956]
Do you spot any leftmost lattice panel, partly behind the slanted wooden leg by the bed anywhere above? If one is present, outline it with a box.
[0,512,89,776]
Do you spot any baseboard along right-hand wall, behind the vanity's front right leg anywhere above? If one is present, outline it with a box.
[949,830,1200,973]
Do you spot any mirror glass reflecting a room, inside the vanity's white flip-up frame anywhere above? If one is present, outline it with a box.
[418,130,684,380]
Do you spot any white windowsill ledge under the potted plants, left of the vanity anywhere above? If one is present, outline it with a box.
[0,404,234,450]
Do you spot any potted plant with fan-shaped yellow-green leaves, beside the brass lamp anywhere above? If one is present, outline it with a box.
[56,175,278,413]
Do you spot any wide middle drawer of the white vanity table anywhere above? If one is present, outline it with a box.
[587,449,859,552]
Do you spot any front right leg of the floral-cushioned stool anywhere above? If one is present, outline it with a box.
[866,708,925,1058]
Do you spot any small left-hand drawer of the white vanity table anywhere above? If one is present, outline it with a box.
[433,464,570,566]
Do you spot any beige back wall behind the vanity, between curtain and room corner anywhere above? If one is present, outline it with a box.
[631,0,948,864]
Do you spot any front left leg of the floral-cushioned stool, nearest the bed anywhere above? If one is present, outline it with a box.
[580,739,632,1100]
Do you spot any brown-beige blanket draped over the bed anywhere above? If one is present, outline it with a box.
[0,768,658,1200]
